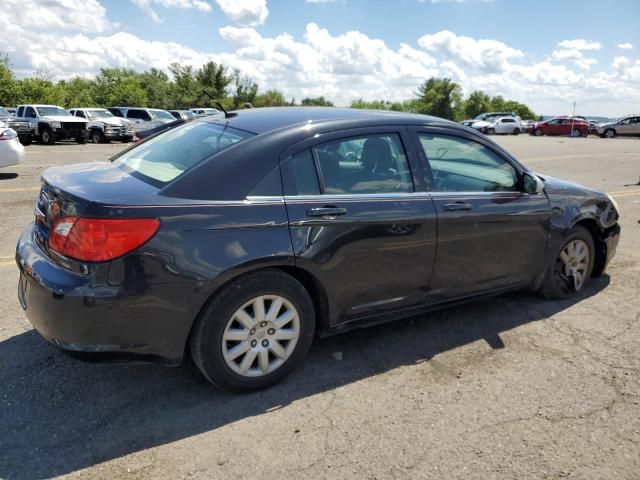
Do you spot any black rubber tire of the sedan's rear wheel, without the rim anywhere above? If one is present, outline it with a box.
[189,270,316,392]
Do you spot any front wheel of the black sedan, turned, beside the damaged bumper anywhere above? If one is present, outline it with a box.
[539,225,595,299]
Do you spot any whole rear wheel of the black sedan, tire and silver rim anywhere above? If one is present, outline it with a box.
[190,270,315,392]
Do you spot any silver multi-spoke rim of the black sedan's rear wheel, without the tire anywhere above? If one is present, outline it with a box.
[222,295,300,377]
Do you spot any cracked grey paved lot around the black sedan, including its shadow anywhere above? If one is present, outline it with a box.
[0,136,640,479]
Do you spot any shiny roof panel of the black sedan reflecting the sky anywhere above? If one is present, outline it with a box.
[209,107,458,134]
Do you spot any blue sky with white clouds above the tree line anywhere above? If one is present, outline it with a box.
[0,0,640,117]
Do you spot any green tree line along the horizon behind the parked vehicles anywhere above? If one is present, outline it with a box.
[0,55,535,121]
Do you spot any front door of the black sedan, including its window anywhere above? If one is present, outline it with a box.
[414,125,551,302]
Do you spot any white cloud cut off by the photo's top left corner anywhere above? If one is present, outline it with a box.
[0,0,114,33]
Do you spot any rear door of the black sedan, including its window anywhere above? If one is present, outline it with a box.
[281,128,436,326]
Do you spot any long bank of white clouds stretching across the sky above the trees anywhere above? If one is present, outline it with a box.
[0,0,640,116]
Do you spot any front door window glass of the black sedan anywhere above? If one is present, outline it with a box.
[419,134,518,192]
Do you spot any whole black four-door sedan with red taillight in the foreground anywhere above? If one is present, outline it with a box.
[16,107,620,391]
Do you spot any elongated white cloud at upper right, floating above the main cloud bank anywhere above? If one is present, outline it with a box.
[418,30,524,72]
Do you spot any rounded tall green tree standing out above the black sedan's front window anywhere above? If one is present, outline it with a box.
[416,78,462,120]
